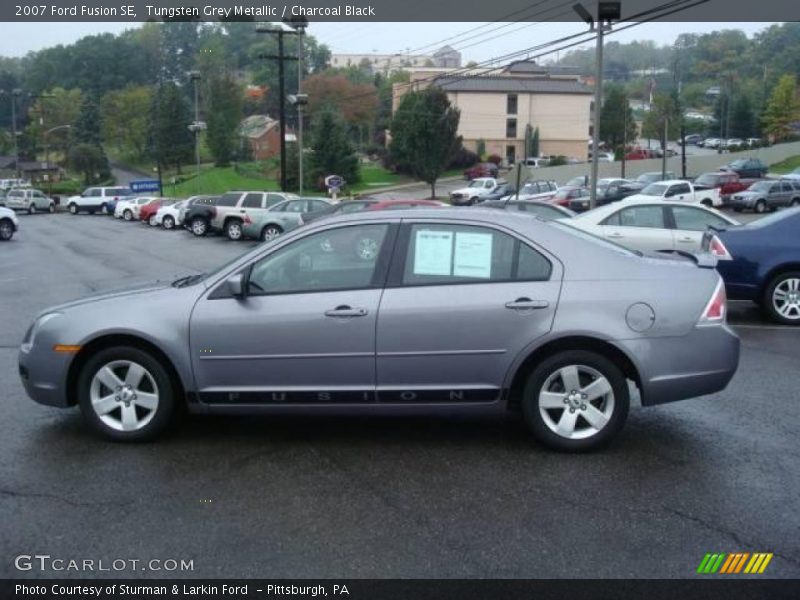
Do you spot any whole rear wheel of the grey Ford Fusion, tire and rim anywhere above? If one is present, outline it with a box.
[522,350,629,452]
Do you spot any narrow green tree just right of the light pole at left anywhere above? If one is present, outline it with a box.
[206,75,242,167]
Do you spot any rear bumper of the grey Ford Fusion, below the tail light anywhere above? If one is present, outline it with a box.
[617,325,739,406]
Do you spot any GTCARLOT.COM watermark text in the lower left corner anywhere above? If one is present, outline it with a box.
[14,554,194,573]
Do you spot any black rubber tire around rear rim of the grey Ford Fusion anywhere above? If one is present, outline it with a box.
[522,350,630,452]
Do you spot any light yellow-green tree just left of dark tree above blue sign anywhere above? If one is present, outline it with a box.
[100,85,153,159]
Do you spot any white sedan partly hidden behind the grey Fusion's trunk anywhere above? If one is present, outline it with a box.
[563,197,740,252]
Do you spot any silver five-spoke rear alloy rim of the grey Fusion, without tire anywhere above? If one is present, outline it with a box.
[538,365,614,440]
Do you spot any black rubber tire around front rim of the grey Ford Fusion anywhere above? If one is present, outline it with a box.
[77,346,177,442]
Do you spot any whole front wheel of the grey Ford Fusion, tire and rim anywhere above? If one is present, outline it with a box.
[77,346,176,442]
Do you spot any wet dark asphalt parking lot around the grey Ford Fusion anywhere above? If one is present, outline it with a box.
[0,214,800,578]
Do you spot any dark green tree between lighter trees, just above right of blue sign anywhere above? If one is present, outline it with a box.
[148,82,194,172]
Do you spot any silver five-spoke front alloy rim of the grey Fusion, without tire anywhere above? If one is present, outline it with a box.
[89,360,159,431]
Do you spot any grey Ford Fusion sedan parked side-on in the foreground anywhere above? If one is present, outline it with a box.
[19,209,739,451]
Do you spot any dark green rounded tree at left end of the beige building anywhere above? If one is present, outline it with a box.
[389,87,461,198]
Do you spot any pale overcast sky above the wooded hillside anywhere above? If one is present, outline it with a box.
[0,22,770,63]
